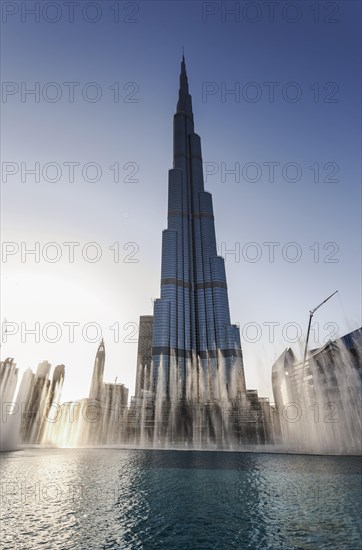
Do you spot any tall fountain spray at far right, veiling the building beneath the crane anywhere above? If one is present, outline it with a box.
[273,329,362,454]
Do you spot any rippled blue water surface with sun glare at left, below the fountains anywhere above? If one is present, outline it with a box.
[1,449,362,550]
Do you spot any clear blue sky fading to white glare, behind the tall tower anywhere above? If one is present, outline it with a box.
[1,0,361,406]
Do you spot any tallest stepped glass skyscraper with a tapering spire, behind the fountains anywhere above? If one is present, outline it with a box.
[150,57,245,402]
